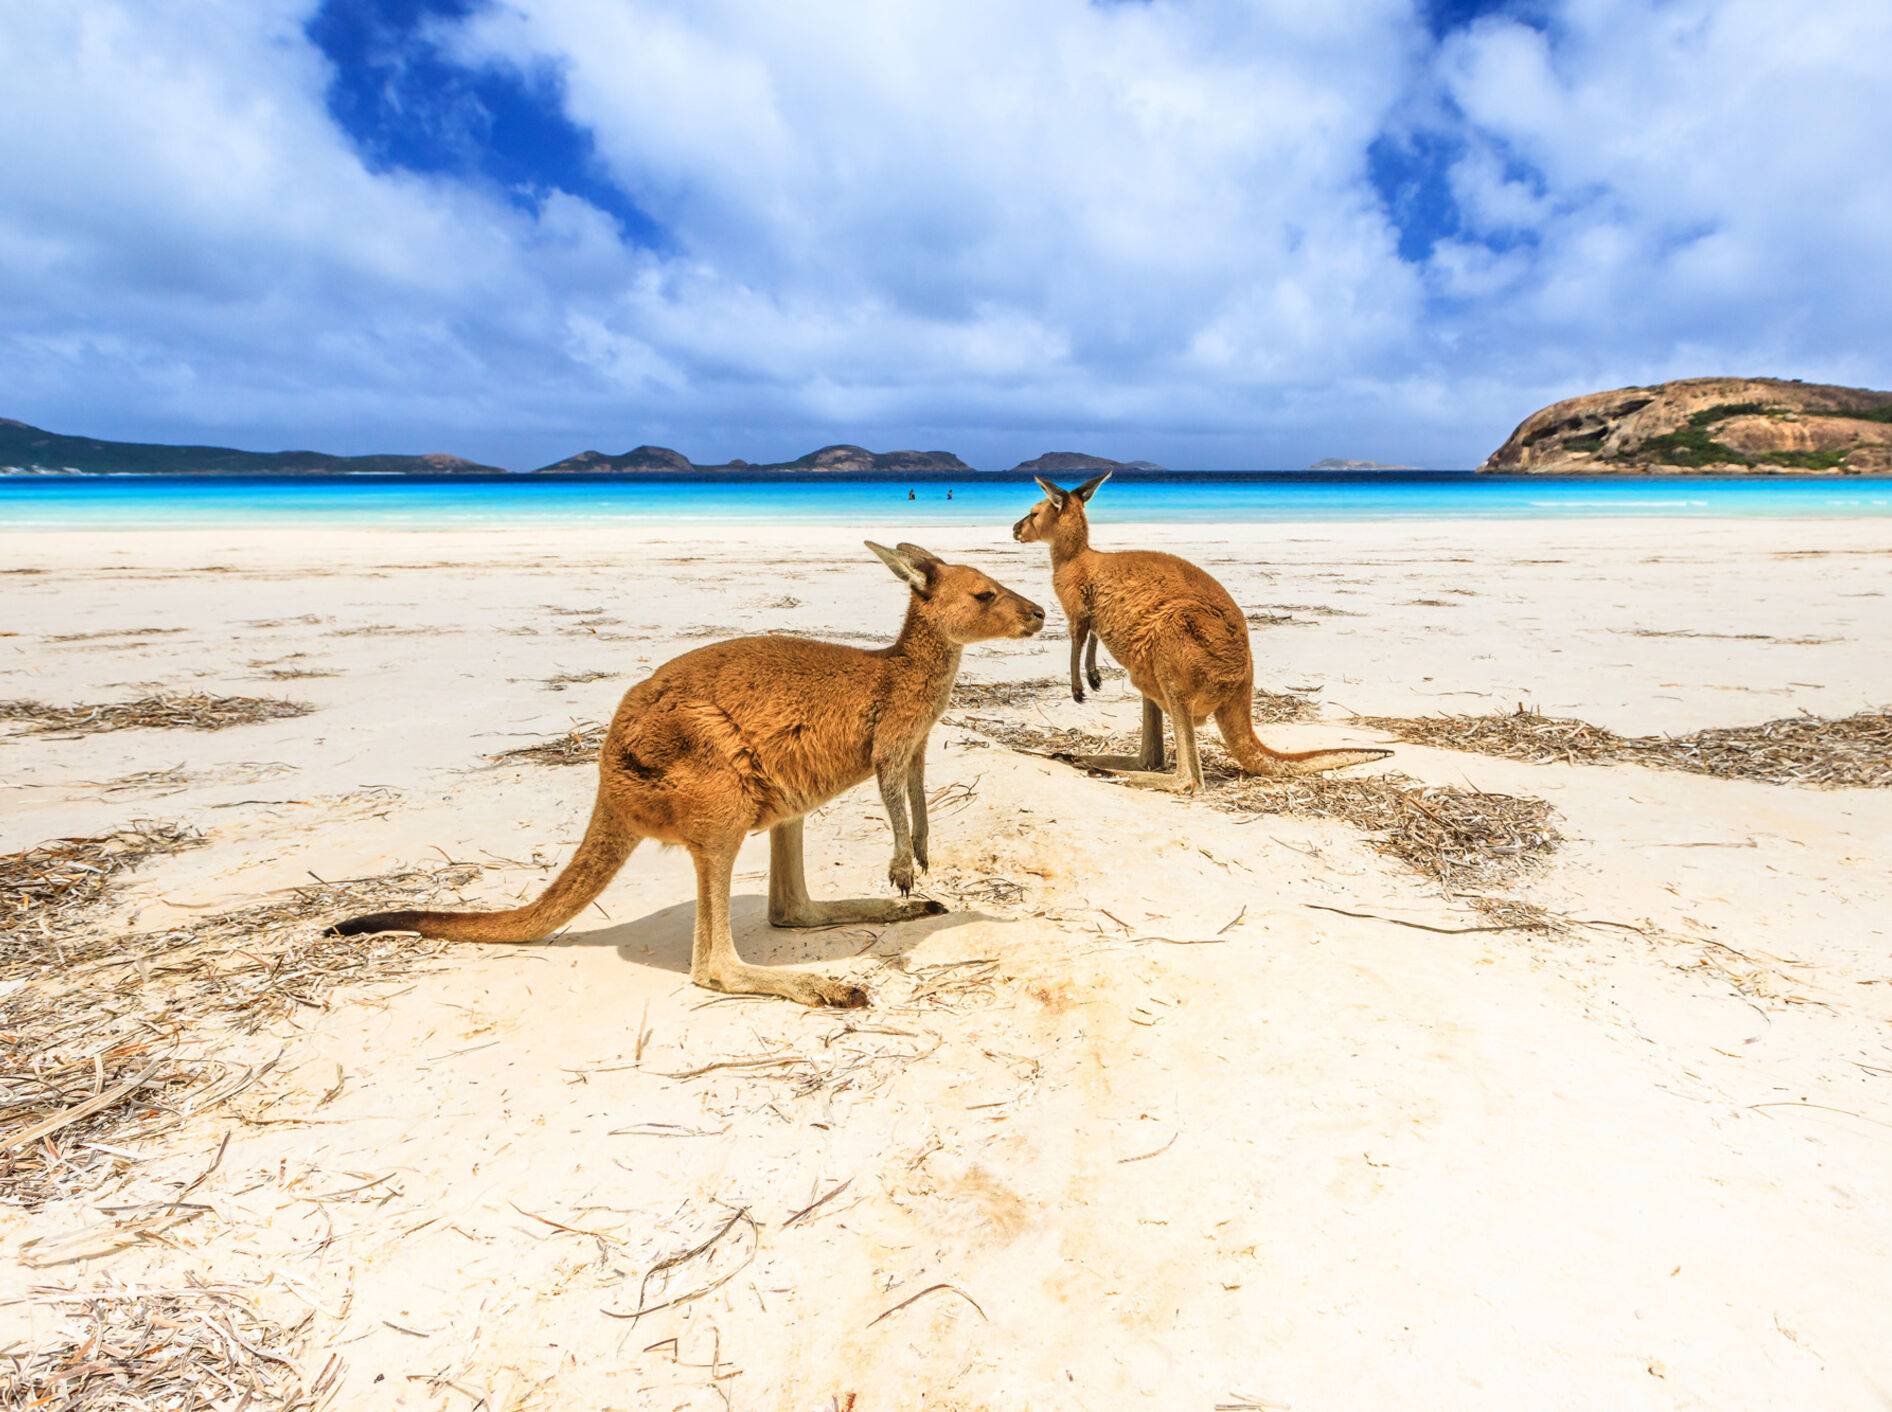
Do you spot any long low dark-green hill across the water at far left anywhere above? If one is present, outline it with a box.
[0,416,505,475]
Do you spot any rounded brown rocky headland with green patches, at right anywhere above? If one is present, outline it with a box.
[1478,377,1892,475]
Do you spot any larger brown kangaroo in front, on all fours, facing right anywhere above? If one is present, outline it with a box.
[329,541,1044,1007]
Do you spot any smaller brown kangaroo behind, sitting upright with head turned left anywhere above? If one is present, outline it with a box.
[1012,471,1393,793]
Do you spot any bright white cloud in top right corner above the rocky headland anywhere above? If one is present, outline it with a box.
[1440,0,1892,374]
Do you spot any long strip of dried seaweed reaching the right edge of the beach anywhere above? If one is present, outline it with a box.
[1360,706,1892,789]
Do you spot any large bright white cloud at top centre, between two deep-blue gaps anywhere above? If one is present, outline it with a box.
[452,0,1411,395]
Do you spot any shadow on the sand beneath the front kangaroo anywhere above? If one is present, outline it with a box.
[552,893,997,975]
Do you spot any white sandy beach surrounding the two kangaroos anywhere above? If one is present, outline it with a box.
[0,519,1892,1412]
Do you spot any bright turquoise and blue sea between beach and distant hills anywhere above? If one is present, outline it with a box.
[0,471,1892,530]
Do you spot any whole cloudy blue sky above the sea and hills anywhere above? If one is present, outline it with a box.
[0,0,1892,468]
